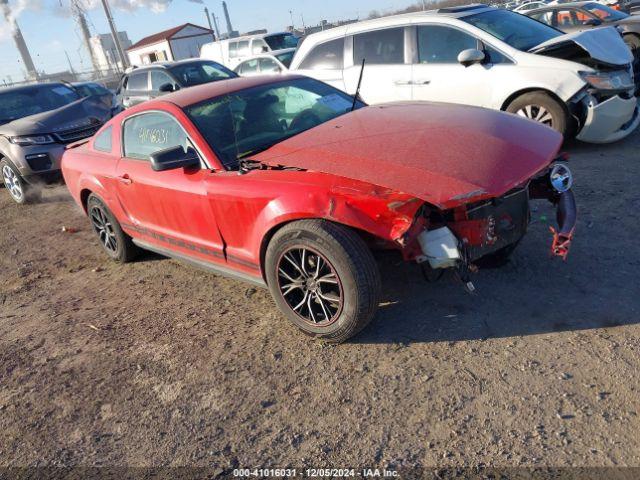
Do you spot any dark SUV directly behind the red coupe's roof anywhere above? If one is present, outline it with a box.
[116,59,238,108]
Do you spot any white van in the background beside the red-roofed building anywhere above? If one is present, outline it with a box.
[200,32,299,70]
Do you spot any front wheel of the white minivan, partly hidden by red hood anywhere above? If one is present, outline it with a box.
[507,92,569,136]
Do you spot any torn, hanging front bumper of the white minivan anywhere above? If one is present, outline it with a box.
[576,95,640,143]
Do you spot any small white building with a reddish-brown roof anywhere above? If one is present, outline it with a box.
[127,23,215,66]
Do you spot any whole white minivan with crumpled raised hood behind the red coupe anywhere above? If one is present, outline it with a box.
[290,5,640,143]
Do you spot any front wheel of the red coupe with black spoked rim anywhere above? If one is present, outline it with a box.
[265,220,381,343]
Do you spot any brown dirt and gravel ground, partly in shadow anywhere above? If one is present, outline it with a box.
[0,132,640,473]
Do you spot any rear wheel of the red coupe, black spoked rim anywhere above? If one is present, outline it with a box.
[87,194,140,263]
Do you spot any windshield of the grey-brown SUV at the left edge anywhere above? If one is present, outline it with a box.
[0,84,80,124]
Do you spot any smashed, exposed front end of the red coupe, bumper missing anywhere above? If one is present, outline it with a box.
[405,158,577,285]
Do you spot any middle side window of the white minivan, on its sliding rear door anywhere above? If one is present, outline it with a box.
[353,28,404,65]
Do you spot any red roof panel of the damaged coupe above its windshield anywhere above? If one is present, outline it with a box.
[149,75,307,109]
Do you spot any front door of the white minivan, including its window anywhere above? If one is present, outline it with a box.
[411,24,506,108]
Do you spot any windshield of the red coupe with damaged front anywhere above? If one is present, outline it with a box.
[185,78,364,168]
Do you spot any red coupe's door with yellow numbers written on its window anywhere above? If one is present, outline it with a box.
[116,111,224,262]
